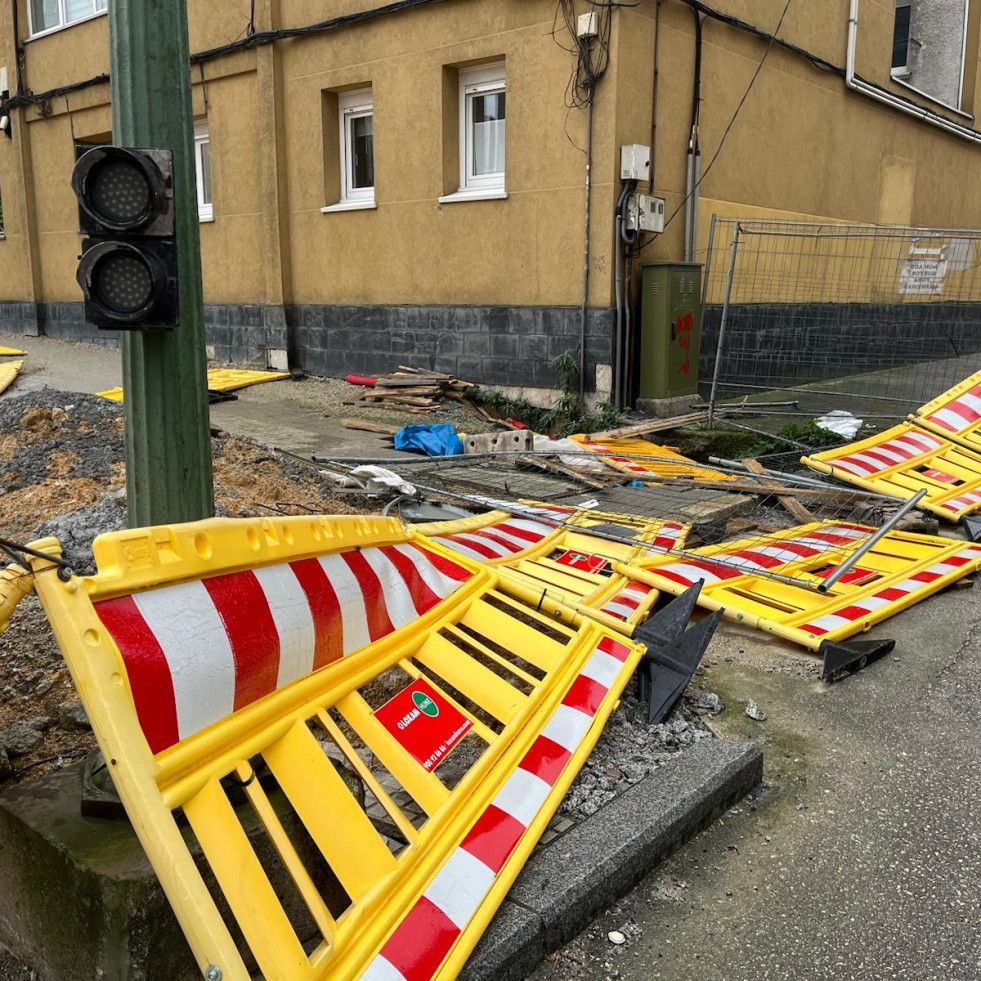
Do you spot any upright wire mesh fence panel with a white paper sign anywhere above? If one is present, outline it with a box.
[700,219,981,430]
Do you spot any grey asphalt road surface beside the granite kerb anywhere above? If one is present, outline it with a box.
[532,587,981,981]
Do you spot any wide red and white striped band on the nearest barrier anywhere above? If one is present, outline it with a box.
[94,544,471,753]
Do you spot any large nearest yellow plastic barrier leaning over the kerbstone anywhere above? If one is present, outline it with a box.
[32,517,643,981]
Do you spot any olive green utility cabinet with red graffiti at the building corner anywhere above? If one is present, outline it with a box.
[638,262,702,399]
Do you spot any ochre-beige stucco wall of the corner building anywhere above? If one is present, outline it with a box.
[0,0,981,386]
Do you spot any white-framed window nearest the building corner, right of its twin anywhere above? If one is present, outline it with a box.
[460,62,507,191]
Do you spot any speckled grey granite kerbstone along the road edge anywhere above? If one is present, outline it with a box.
[460,739,763,981]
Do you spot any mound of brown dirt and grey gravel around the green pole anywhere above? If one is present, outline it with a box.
[0,389,358,786]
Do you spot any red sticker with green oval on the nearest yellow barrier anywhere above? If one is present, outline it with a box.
[375,678,473,771]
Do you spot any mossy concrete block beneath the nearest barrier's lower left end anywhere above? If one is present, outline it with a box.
[0,765,345,981]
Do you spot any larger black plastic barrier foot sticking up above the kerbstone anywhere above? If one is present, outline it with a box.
[633,582,722,726]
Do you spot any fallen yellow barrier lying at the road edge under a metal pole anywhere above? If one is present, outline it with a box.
[624,521,981,650]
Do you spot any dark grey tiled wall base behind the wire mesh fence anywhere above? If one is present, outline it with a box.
[699,303,981,395]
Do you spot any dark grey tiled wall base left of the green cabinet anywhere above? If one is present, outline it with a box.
[0,303,613,390]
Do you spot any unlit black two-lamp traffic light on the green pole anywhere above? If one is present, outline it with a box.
[72,145,179,330]
